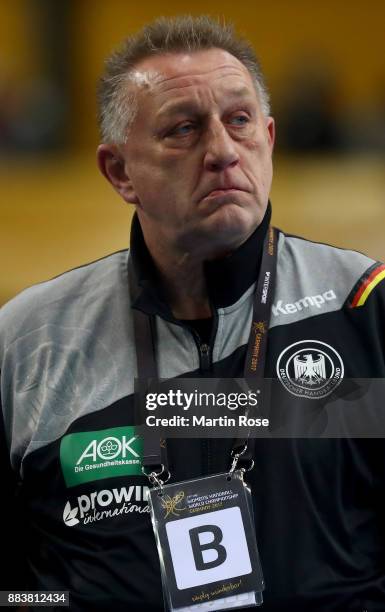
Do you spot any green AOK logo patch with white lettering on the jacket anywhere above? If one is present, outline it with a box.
[60,427,143,487]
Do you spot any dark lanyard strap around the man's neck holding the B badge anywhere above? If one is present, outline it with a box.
[129,227,278,482]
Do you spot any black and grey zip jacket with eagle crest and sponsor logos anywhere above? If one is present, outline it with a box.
[0,210,385,612]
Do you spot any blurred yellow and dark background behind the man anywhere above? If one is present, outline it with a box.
[0,0,385,303]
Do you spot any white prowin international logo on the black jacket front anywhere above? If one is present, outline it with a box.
[63,485,150,527]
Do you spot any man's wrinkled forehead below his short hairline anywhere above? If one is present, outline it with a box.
[132,49,254,97]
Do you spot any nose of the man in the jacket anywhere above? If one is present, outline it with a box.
[204,122,239,172]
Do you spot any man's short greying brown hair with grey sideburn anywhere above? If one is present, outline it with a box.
[98,15,270,144]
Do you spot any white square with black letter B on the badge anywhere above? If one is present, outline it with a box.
[166,507,252,589]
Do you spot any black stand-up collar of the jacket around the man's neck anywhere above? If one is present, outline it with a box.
[130,202,271,321]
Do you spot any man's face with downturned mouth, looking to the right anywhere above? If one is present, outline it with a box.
[116,49,274,258]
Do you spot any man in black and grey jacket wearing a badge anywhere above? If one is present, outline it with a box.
[1,17,385,612]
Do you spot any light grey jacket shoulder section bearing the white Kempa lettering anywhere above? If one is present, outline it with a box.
[273,231,385,324]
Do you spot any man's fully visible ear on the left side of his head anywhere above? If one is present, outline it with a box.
[96,144,139,204]
